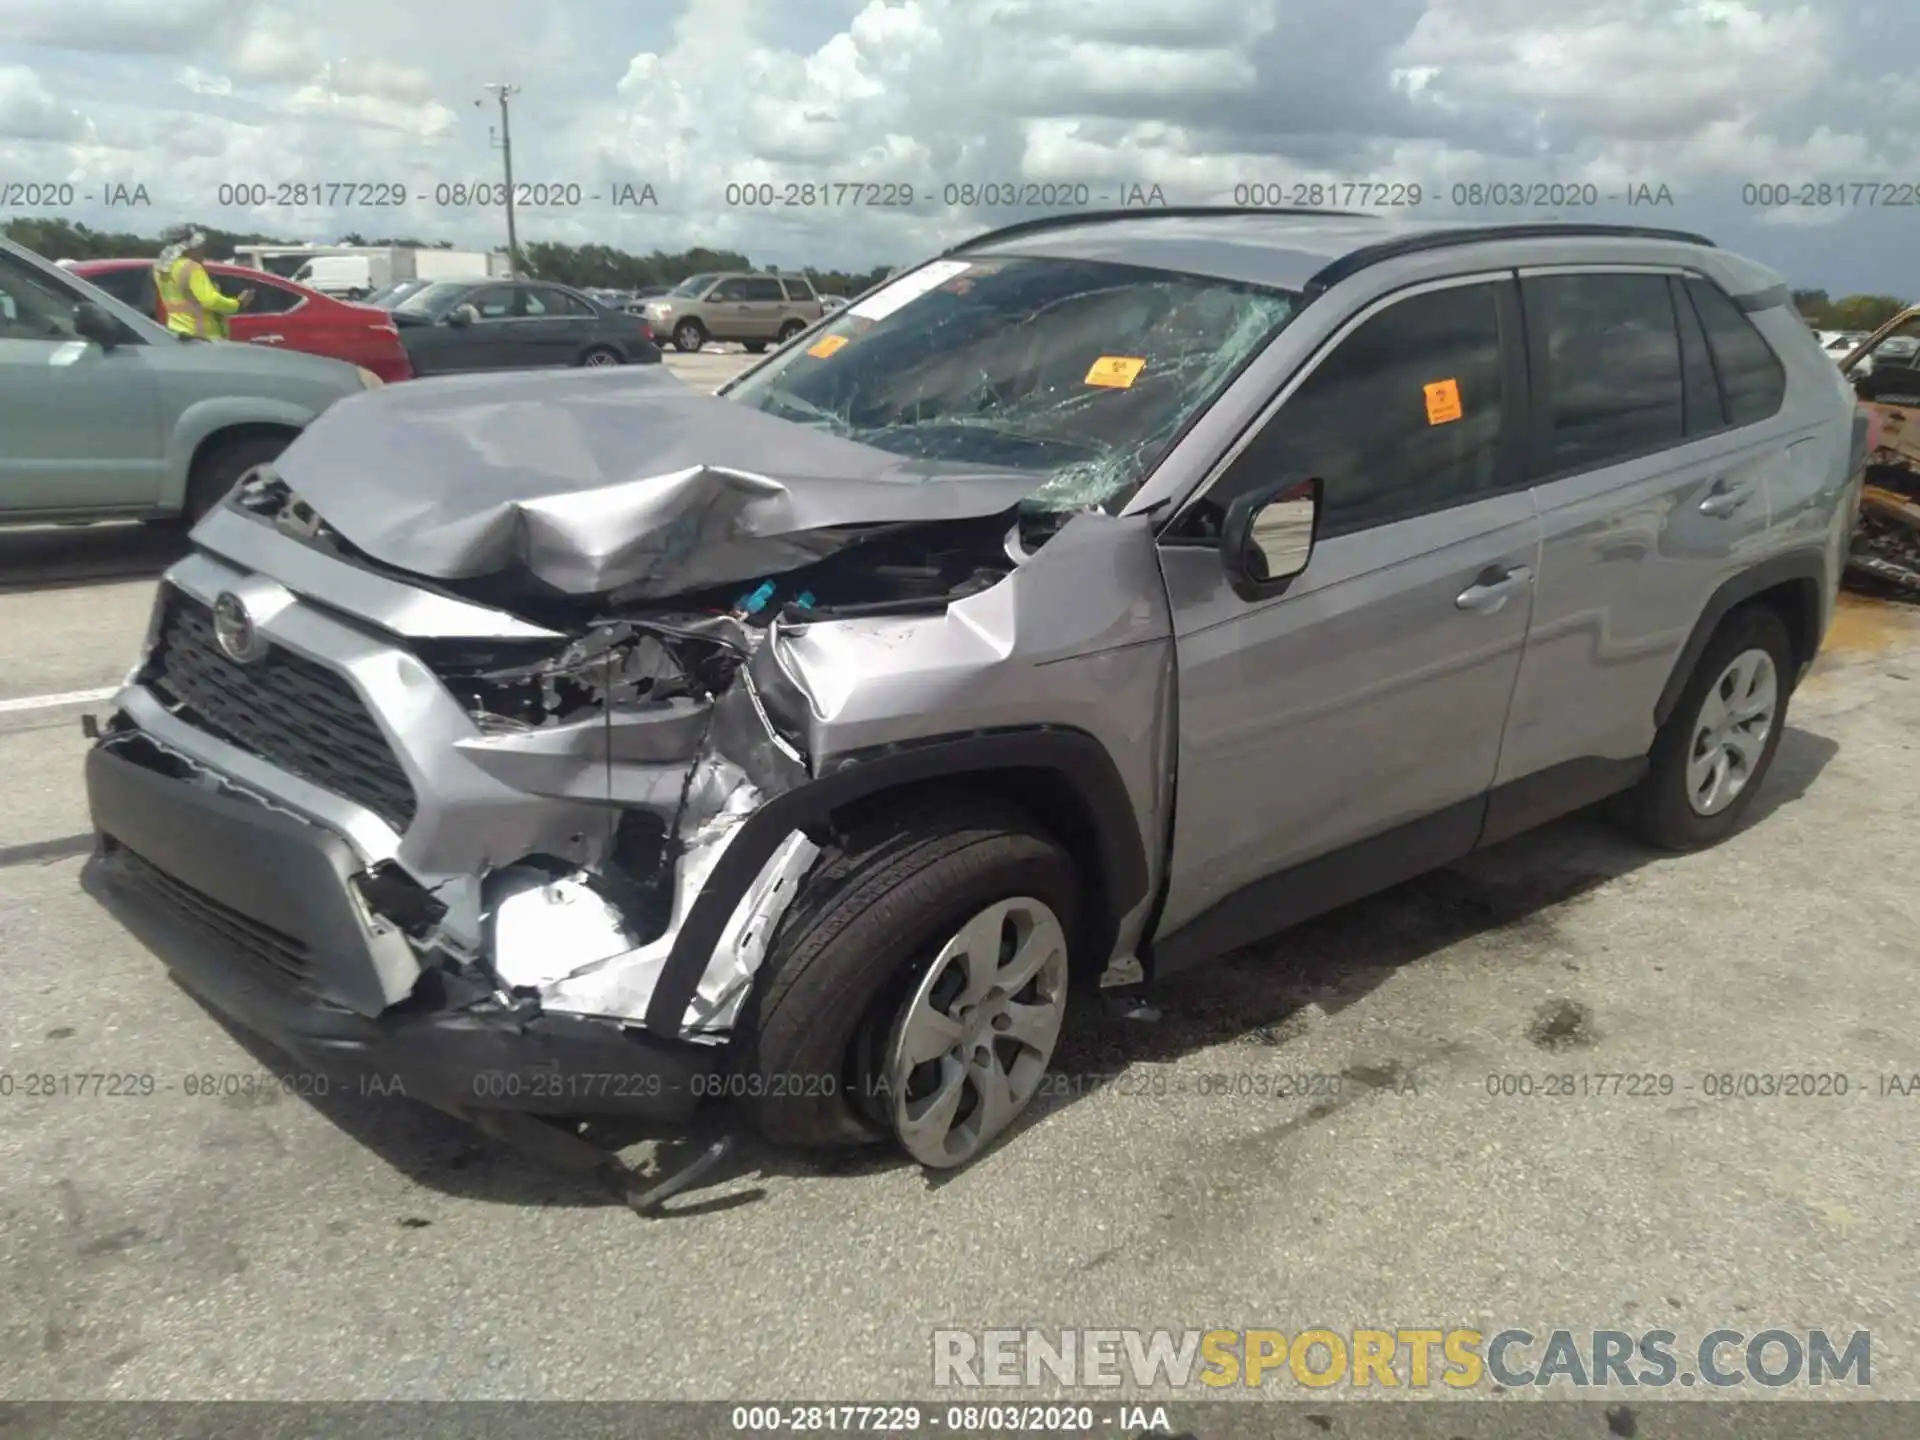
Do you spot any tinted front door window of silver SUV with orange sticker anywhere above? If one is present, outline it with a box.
[1188,284,1509,538]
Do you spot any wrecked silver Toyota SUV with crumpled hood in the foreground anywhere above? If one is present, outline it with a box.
[86,209,1864,1167]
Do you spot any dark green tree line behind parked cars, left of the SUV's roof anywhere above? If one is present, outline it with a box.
[0,217,893,296]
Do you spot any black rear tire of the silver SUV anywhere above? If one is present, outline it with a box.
[1619,605,1797,851]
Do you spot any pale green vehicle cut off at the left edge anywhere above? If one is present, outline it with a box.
[0,240,380,524]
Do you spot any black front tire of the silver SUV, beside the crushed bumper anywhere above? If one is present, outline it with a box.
[732,804,1081,1167]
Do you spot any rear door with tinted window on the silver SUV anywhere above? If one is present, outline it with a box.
[1490,267,1786,806]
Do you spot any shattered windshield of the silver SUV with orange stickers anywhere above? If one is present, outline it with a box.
[722,259,1300,511]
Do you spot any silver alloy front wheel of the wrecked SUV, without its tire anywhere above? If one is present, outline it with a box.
[885,895,1068,1169]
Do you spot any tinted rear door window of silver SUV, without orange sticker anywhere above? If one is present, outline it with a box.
[1523,273,1686,474]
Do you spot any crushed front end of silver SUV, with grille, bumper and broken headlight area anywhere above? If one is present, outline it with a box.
[86,476,1036,1119]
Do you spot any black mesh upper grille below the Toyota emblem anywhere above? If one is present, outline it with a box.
[142,591,419,829]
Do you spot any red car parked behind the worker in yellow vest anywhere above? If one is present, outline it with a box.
[65,259,413,384]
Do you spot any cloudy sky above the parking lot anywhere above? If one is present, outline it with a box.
[0,0,1920,296]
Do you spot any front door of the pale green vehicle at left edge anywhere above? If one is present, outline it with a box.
[0,252,167,516]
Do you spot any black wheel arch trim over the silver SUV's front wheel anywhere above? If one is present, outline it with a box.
[647,726,1148,1035]
